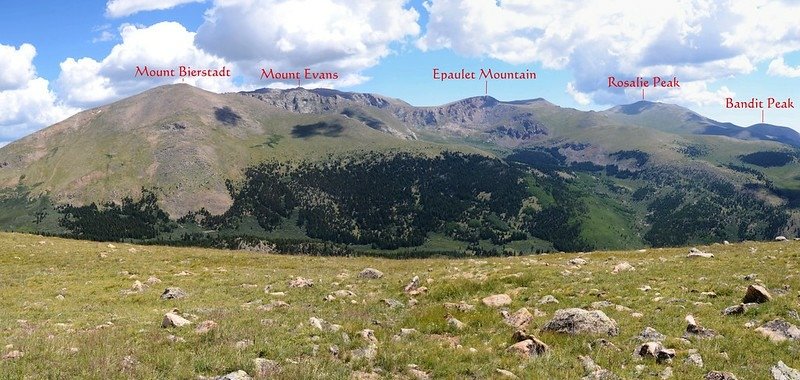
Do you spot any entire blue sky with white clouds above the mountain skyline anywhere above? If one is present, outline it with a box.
[0,0,800,144]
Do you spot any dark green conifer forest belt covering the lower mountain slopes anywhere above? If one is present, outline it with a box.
[6,147,789,257]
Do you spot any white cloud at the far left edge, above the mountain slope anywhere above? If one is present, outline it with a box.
[0,44,78,143]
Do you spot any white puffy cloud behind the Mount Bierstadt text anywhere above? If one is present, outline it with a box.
[58,22,237,107]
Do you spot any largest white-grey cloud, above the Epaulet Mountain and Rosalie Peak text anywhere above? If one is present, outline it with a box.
[417,0,800,104]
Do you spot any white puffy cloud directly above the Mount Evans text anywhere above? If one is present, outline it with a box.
[196,0,419,86]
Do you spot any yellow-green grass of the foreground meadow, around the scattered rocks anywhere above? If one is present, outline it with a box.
[0,233,800,379]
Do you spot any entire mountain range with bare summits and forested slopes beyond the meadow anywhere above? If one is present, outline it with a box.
[0,84,800,257]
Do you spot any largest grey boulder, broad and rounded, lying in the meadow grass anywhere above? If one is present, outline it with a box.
[542,308,619,335]
